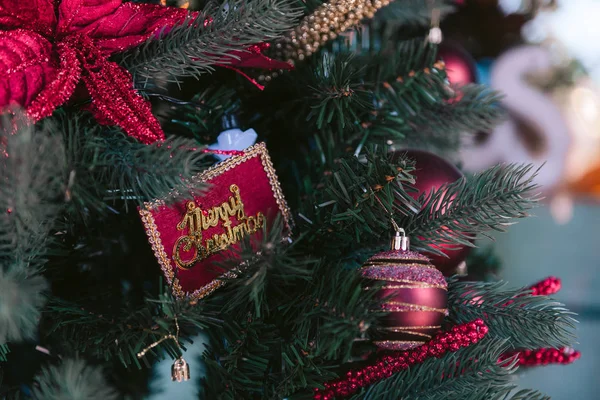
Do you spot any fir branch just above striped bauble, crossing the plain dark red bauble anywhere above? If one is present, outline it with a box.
[301,149,537,260]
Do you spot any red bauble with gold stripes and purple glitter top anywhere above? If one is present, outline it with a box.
[361,251,448,350]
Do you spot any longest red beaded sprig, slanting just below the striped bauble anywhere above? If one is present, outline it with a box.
[313,319,488,400]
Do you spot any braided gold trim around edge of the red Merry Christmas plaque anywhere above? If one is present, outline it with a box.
[139,143,294,299]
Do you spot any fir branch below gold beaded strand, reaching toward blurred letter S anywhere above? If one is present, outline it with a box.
[250,40,504,155]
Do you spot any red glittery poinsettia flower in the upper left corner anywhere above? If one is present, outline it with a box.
[0,0,292,143]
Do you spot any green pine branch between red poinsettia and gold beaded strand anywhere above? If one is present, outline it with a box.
[121,0,300,86]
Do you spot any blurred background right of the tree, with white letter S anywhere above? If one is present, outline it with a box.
[442,0,600,399]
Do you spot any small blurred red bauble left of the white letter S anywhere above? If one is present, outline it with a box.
[438,40,477,85]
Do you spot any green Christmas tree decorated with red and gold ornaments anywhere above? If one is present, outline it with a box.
[0,0,578,399]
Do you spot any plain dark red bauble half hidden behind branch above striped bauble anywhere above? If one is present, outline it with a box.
[396,150,471,276]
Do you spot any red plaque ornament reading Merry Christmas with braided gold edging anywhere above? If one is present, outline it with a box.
[139,143,292,298]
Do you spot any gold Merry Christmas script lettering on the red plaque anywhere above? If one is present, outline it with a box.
[173,184,265,269]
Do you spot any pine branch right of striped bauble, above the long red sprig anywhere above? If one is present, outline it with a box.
[448,280,576,349]
